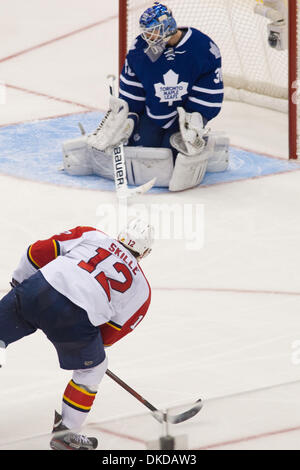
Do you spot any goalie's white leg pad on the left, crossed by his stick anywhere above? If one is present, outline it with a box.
[62,136,174,187]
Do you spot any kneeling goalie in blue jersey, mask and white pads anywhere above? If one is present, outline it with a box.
[64,2,229,191]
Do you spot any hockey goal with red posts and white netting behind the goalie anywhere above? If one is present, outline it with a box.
[120,0,300,158]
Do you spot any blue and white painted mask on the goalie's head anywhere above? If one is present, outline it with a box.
[140,2,177,59]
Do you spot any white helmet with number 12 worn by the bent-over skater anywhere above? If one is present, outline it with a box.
[117,218,154,259]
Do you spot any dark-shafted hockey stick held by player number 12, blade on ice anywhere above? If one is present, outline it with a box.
[106,369,203,424]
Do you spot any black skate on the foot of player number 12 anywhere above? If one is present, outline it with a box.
[50,411,98,450]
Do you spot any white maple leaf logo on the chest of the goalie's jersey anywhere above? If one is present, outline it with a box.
[154,70,188,106]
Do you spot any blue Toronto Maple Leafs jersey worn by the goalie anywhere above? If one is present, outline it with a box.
[120,28,224,129]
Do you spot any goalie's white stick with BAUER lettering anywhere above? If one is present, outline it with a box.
[107,75,156,199]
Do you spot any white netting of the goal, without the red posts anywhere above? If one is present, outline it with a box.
[127,0,288,112]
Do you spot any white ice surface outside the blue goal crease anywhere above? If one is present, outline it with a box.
[0,0,300,449]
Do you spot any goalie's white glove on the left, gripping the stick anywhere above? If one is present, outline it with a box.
[87,96,134,151]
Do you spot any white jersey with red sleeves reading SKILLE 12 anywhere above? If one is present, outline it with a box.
[13,227,151,346]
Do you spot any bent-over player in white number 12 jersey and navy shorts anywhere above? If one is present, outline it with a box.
[0,219,153,450]
